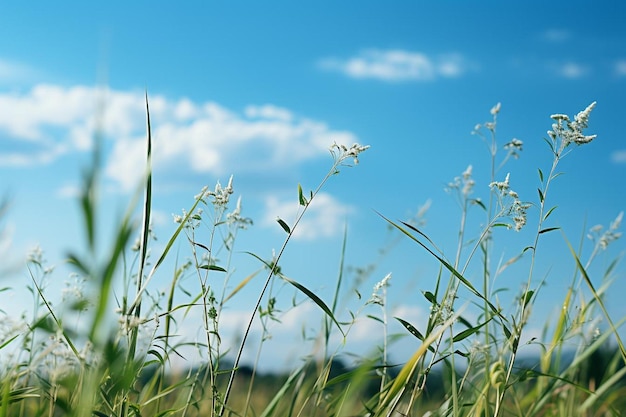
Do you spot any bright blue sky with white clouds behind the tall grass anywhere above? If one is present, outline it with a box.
[0,1,626,368]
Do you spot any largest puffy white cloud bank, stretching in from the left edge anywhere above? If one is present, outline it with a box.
[0,84,357,190]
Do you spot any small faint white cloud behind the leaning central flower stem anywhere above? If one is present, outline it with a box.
[262,193,354,240]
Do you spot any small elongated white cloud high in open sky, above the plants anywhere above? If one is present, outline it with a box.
[319,49,468,81]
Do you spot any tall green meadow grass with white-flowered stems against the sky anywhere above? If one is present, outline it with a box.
[0,97,626,417]
